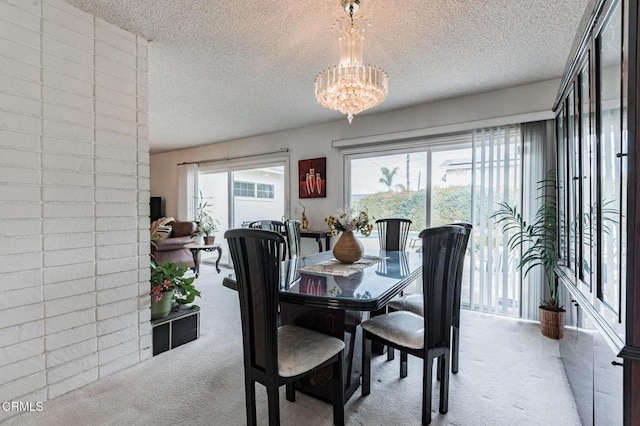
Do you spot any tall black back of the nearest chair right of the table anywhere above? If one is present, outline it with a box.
[419,225,466,349]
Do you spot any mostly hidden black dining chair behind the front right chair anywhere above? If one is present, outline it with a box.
[388,222,473,372]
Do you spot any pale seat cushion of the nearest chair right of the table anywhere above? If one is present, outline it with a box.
[361,311,424,349]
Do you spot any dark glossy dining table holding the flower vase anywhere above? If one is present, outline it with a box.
[223,250,422,403]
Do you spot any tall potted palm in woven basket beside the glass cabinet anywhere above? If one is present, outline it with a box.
[491,172,565,339]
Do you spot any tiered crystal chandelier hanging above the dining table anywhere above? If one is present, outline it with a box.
[315,0,389,124]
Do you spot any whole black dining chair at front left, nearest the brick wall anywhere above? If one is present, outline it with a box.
[224,229,344,426]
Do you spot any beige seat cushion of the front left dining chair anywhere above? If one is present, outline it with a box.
[278,325,344,377]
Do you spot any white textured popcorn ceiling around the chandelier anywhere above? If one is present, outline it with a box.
[66,0,593,153]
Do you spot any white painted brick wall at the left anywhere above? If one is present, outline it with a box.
[0,0,151,422]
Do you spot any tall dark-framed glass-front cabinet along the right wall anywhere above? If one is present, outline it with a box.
[554,0,640,425]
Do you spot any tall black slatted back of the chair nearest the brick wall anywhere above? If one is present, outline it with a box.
[224,228,284,373]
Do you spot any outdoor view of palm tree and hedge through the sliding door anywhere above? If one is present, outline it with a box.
[350,148,471,298]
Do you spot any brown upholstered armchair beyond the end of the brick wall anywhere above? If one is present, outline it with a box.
[151,221,200,270]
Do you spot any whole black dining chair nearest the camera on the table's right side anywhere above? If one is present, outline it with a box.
[361,225,465,424]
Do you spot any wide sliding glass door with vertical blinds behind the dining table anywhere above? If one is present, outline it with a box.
[345,126,521,316]
